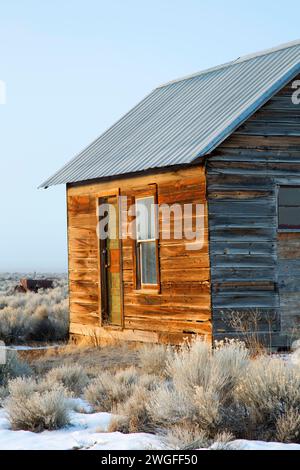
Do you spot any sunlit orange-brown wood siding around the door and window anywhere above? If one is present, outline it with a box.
[67,166,211,342]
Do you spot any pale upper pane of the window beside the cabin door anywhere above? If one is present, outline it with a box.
[136,197,155,240]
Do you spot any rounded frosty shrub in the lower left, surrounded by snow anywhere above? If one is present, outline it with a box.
[5,378,69,432]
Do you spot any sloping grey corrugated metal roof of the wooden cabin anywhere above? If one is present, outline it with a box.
[41,41,300,188]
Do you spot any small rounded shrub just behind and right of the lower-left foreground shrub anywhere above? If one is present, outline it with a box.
[46,364,89,396]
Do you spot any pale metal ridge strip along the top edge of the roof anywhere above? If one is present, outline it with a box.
[156,39,300,88]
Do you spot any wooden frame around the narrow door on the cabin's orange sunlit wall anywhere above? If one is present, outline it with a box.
[95,188,124,330]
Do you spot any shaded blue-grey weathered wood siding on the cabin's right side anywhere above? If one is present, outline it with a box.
[207,72,300,346]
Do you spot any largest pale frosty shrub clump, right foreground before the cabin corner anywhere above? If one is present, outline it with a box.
[147,339,300,441]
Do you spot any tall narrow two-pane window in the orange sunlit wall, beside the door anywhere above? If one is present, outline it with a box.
[135,196,158,289]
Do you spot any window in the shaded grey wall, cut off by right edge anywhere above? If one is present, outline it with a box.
[278,186,300,230]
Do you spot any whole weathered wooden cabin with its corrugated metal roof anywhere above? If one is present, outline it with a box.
[42,41,300,348]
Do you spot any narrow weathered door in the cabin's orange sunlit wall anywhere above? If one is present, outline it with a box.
[99,195,123,326]
